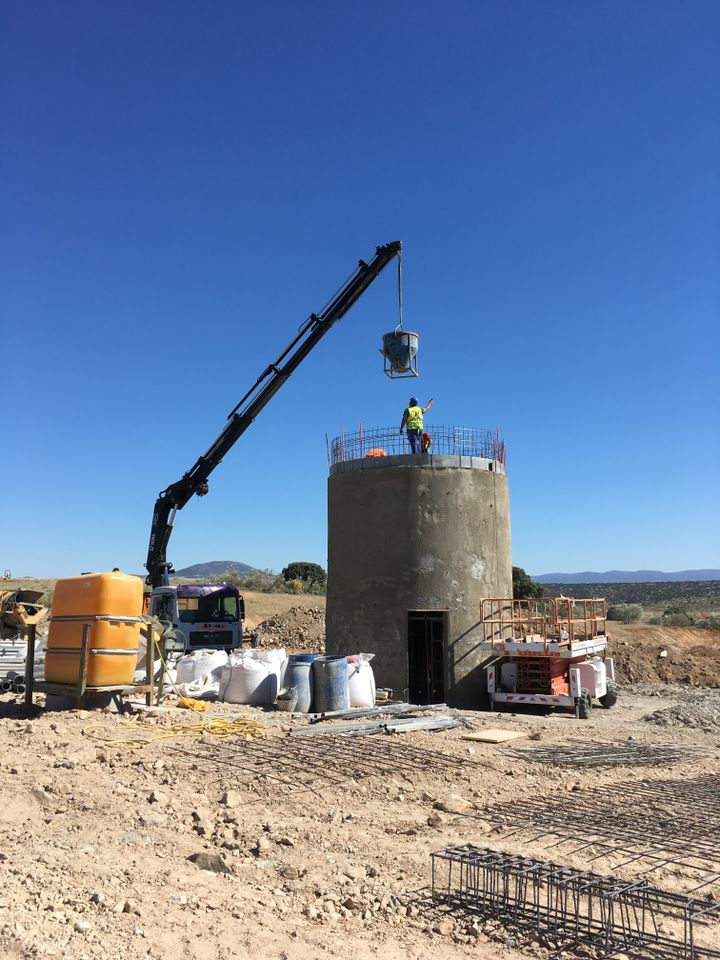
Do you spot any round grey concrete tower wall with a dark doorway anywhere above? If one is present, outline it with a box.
[327,456,512,707]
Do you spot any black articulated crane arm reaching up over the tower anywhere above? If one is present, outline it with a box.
[145,240,402,588]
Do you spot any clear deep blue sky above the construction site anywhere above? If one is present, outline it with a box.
[0,0,720,576]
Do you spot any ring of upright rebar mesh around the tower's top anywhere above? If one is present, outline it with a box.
[325,423,506,467]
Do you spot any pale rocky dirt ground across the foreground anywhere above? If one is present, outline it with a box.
[0,686,720,960]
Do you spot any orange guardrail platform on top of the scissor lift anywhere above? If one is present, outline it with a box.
[480,597,607,645]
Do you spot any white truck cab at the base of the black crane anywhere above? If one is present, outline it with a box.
[150,583,245,651]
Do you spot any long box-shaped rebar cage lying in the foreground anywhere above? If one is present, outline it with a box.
[431,844,720,960]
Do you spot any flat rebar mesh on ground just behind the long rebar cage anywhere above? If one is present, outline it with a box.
[481,773,720,893]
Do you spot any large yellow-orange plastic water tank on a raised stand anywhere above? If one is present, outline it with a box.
[45,570,143,687]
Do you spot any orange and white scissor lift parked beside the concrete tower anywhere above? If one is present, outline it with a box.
[480,597,617,719]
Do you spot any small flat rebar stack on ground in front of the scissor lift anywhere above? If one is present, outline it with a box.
[512,742,700,767]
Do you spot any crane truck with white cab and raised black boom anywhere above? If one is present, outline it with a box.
[145,240,402,650]
